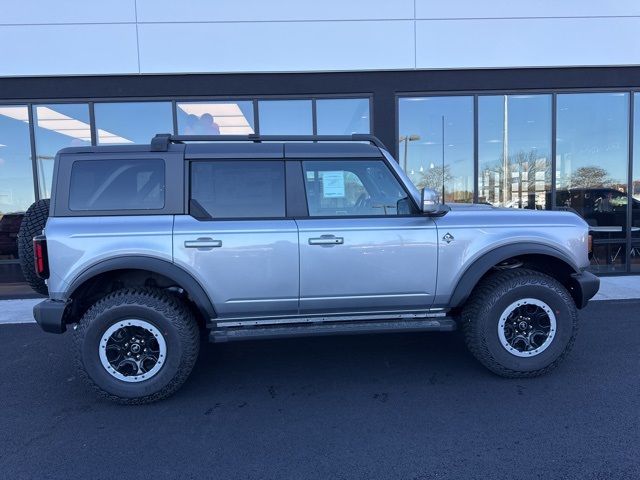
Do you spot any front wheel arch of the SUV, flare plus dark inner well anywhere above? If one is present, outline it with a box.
[449,242,582,308]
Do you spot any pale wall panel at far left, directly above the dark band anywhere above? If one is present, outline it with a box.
[0,24,138,76]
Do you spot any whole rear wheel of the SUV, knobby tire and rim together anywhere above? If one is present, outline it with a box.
[75,288,200,404]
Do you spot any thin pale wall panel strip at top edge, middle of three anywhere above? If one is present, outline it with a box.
[138,0,413,22]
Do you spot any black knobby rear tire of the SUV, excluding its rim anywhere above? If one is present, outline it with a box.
[74,288,200,405]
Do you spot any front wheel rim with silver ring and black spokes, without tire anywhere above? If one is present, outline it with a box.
[498,298,556,357]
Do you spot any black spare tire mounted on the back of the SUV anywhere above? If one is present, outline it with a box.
[18,198,49,295]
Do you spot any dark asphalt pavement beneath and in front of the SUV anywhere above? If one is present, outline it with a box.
[0,301,640,480]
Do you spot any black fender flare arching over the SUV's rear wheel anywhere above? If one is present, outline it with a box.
[64,255,216,323]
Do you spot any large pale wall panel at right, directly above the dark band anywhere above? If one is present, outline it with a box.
[416,18,640,68]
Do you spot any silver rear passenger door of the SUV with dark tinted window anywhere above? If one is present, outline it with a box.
[173,144,299,318]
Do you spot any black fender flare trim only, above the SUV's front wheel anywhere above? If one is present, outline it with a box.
[449,242,580,308]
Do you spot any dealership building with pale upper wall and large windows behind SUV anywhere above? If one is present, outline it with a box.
[0,0,640,283]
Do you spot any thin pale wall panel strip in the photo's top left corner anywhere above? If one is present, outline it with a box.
[0,0,136,25]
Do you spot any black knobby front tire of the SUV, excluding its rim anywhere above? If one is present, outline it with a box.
[461,268,578,378]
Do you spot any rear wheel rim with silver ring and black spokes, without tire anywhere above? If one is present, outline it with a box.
[100,319,167,382]
